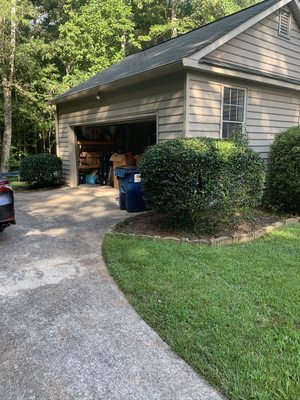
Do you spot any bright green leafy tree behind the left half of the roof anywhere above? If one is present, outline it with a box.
[57,0,134,86]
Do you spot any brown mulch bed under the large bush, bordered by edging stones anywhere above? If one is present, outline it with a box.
[115,209,289,240]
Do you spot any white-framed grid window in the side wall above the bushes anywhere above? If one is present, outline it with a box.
[222,87,246,139]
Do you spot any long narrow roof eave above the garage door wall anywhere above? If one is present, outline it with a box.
[48,59,183,104]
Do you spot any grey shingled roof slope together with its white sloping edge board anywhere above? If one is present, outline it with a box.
[53,0,300,102]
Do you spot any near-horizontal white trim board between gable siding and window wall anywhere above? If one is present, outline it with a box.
[184,58,300,92]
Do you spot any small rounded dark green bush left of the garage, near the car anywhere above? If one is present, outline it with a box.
[20,154,62,187]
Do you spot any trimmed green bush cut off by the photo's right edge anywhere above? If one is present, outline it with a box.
[267,126,300,213]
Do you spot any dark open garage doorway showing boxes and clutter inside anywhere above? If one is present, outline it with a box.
[74,118,157,187]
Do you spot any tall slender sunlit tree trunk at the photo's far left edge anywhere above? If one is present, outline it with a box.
[0,0,17,172]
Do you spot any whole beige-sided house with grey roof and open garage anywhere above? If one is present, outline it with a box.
[52,0,300,186]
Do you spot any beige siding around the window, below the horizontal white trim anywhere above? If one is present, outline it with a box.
[186,72,300,158]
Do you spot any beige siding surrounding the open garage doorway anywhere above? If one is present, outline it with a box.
[58,74,184,184]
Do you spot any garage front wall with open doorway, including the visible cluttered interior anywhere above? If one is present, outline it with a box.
[52,71,185,187]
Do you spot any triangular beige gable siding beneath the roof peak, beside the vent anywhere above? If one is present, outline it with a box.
[204,11,300,80]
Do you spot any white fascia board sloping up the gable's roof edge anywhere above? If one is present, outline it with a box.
[189,0,292,60]
